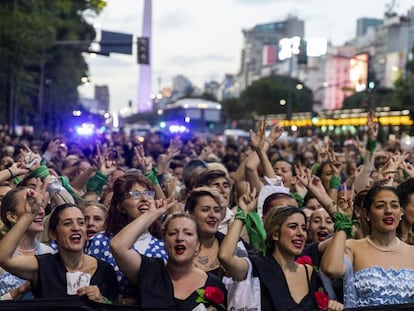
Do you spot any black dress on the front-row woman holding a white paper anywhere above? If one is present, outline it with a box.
[31,253,119,300]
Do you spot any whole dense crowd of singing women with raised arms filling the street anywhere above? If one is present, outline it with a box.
[0,113,414,310]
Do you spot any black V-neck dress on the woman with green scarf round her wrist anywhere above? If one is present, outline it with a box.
[249,255,323,311]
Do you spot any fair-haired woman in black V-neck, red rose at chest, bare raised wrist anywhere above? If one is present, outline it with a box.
[110,200,226,310]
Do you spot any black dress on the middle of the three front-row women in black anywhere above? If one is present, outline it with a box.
[137,256,227,310]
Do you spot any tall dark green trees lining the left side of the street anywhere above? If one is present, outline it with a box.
[0,0,105,134]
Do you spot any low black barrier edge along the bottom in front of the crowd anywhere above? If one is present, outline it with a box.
[0,298,414,311]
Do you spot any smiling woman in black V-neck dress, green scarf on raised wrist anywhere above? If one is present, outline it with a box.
[219,186,342,310]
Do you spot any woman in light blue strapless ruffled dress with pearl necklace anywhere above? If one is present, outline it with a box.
[321,186,414,308]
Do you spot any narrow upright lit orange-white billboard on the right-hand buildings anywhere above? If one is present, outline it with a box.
[349,53,369,92]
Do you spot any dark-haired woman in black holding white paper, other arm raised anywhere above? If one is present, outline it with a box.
[0,189,118,302]
